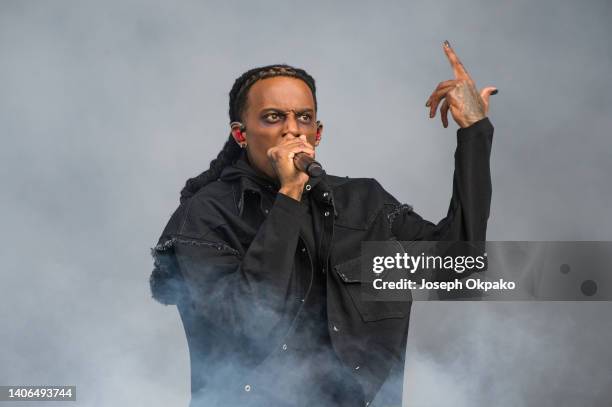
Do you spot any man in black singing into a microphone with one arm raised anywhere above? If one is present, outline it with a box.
[151,42,496,406]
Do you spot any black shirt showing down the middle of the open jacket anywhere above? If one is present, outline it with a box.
[243,154,365,407]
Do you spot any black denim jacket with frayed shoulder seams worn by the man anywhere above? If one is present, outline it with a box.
[150,118,493,406]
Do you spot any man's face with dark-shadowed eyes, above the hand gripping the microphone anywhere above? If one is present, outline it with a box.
[243,76,320,178]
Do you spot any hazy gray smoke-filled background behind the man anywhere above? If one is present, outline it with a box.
[0,0,612,406]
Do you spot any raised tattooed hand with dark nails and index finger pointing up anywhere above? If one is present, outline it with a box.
[425,41,497,128]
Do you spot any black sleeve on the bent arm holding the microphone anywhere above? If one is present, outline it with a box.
[151,193,307,337]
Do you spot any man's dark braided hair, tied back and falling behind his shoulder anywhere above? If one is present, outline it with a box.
[181,64,317,203]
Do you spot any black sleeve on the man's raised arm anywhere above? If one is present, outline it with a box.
[387,117,493,241]
